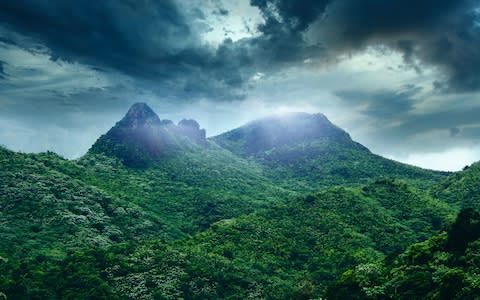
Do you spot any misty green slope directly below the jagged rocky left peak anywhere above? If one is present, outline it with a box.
[78,145,294,238]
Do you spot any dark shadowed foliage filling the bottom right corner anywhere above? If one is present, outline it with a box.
[327,209,480,299]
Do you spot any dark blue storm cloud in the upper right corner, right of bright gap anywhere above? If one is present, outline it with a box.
[251,0,480,91]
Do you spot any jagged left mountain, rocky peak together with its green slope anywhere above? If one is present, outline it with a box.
[79,103,293,238]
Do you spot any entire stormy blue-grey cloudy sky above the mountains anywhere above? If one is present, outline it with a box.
[0,0,480,171]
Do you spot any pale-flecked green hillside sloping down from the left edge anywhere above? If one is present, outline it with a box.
[0,148,156,258]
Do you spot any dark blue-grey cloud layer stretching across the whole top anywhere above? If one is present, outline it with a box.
[0,0,480,98]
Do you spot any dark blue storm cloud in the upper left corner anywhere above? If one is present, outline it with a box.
[0,0,193,69]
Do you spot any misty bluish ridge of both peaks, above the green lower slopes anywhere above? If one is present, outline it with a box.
[89,103,446,189]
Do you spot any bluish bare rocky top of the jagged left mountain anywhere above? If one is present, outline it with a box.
[90,103,207,167]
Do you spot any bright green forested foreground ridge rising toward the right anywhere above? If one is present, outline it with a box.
[4,181,453,299]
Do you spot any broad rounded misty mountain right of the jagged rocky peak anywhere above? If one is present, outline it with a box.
[212,113,446,190]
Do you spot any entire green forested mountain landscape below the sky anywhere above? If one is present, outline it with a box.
[0,103,480,299]
